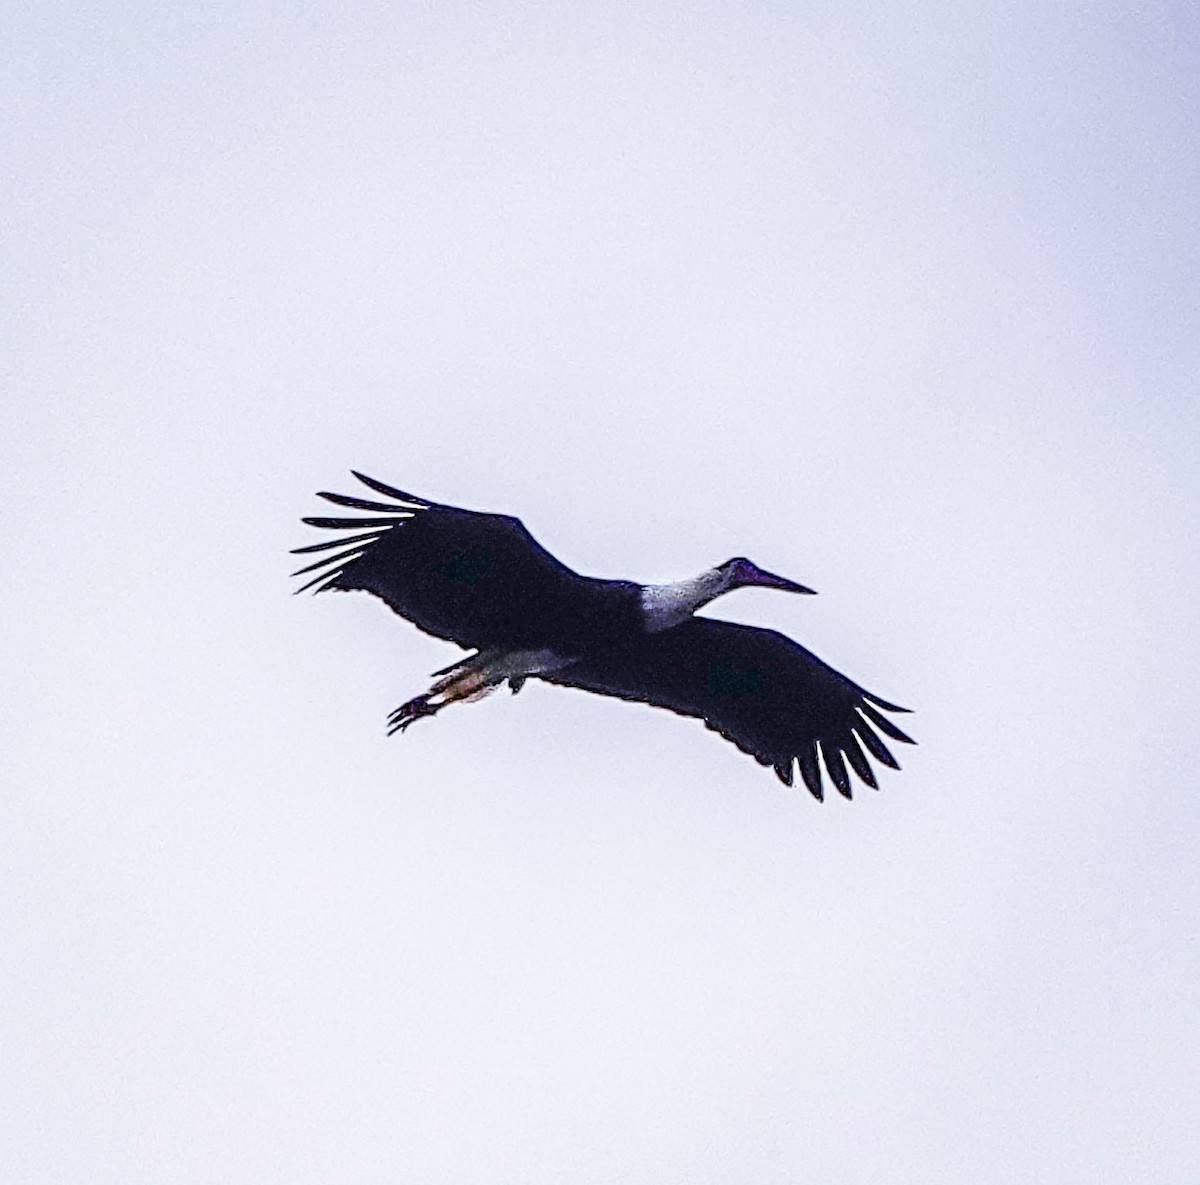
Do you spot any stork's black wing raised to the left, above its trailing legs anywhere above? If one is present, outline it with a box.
[293,473,598,648]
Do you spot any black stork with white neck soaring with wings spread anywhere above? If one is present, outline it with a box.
[293,470,913,800]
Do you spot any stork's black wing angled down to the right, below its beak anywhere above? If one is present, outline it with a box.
[538,618,913,799]
